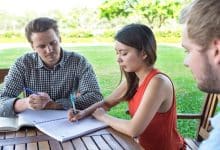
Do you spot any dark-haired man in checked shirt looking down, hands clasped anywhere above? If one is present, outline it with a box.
[0,17,103,117]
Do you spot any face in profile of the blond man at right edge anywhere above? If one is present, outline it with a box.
[182,27,220,93]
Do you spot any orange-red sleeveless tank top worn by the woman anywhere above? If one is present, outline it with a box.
[129,69,185,150]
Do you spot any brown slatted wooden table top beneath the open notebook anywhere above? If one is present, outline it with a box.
[0,127,140,150]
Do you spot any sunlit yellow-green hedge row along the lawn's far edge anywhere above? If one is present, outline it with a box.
[0,29,181,43]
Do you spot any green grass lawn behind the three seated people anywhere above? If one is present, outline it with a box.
[0,45,204,137]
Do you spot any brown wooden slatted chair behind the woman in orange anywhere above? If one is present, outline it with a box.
[177,93,219,150]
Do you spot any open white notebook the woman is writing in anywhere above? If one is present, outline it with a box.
[19,110,107,142]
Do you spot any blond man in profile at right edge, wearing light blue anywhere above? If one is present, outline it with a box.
[180,0,220,149]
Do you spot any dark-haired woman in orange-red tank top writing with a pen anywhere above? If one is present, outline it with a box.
[68,24,185,150]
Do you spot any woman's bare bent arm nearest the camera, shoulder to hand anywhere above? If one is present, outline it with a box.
[93,75,173,137]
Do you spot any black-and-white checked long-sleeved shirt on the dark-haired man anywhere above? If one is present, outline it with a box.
[0,50,103,116]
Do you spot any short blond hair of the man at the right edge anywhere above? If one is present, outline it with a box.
[180,0,220,48]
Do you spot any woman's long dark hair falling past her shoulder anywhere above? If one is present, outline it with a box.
[115,24,157,100]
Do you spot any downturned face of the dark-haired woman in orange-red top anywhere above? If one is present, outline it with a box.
[115,41,147,72]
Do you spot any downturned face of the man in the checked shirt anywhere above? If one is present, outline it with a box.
[31,29,61,68]
